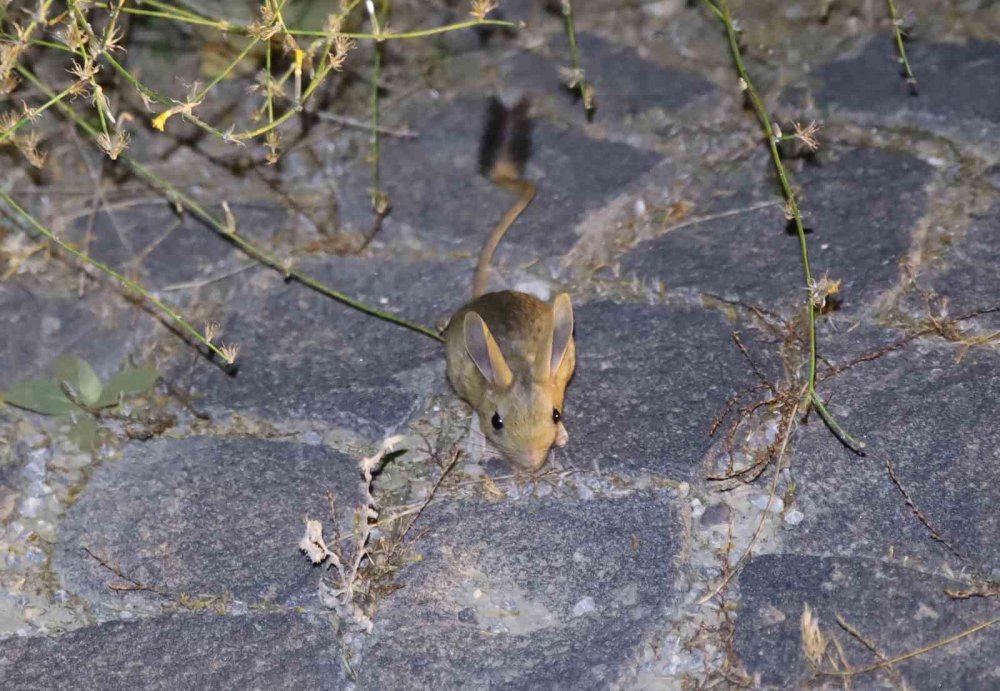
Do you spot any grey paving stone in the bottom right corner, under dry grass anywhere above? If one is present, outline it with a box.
[735,554,1000,691]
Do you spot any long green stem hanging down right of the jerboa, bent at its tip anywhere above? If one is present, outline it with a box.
[704,0,864,453]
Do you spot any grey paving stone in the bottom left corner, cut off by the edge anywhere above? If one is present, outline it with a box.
[0,614,346,691]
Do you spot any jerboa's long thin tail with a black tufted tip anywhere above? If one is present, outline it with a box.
[472,98,535,298]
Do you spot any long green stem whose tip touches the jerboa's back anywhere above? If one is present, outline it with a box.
[18,65,444,341]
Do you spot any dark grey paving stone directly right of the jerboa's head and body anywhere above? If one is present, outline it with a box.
[561,302,764,480]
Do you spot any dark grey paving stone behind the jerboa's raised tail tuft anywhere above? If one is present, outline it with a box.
[343,98,659,263]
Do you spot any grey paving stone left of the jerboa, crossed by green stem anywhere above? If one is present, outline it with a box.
[183,259,460,440]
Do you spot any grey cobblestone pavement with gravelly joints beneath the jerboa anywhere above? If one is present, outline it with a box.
[0,0,1000,689]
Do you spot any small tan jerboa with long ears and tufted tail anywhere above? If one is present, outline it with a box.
[444,99,576,471]
